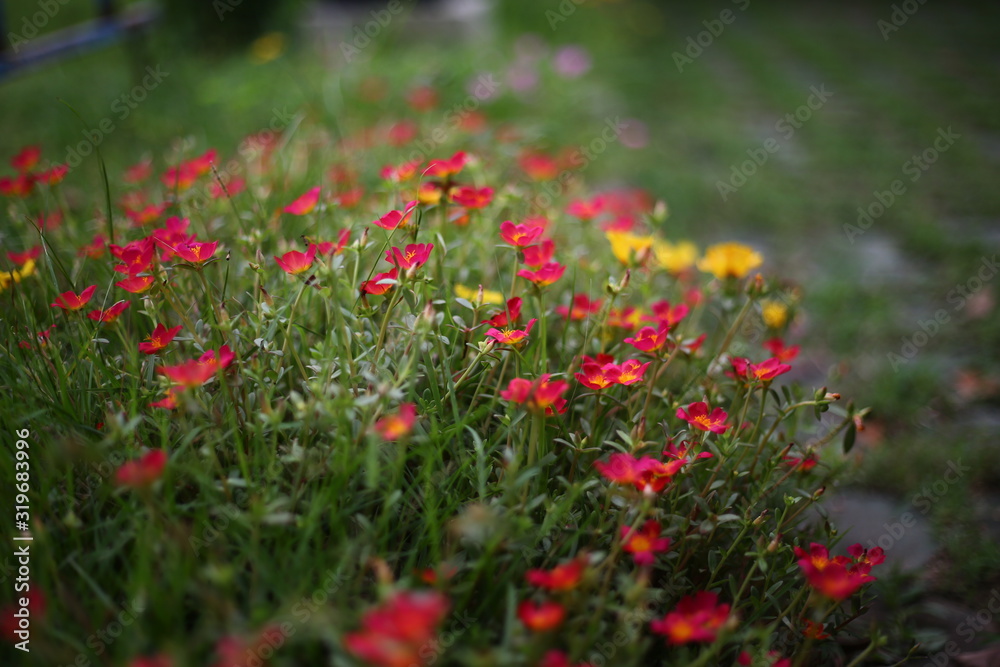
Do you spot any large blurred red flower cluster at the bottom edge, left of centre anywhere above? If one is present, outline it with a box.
[344,591,450,667]
